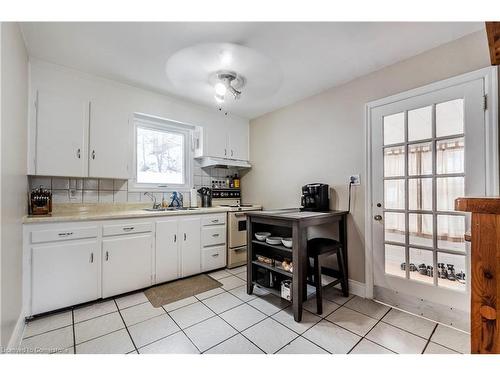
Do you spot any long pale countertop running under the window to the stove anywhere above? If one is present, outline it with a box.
[23,203,262,224]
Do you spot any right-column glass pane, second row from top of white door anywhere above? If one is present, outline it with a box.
[436,137,464,174]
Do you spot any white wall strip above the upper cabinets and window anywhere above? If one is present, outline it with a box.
[28,59,249,174]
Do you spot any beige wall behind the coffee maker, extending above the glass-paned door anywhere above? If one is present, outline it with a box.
[242,32,490,282]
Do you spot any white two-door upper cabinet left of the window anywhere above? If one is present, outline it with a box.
[31,90,132,179]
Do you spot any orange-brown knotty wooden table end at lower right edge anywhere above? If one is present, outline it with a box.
[455,198,500,354]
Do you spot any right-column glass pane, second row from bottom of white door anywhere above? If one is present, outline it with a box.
[437,215,465,252]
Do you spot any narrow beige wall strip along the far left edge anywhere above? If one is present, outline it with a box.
[0,23,28,348]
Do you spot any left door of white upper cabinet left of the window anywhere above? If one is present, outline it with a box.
[35,91,89,177]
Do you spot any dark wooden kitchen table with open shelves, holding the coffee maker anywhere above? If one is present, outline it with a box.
[247,209,348,322]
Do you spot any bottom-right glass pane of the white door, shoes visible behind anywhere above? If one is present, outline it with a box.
[436,252,467,291]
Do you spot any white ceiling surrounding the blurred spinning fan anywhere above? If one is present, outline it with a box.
[22,22,484,118]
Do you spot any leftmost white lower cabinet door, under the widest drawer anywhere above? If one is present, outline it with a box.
[31,239,101,315]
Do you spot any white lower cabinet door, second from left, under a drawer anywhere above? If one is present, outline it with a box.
[102,233,153,298]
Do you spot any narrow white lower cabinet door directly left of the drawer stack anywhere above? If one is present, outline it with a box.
[179,217,201,277]
